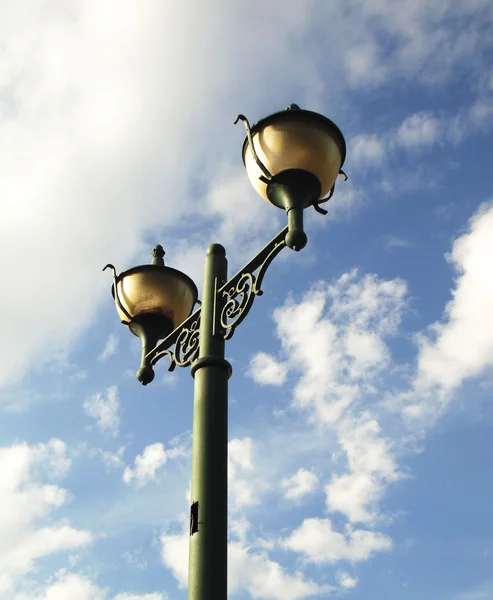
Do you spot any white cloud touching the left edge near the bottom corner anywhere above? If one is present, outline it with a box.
[0,440,93,596]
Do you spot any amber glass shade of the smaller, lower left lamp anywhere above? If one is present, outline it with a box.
[113,265,198,329]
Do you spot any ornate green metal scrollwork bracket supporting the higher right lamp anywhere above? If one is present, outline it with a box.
[219,239,286,340]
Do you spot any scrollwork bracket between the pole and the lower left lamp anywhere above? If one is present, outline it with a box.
[150,309,201,371]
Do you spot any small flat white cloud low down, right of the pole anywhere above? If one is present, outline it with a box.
[282,518,392,564]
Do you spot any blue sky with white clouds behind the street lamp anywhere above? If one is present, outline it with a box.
[0,0,493,600]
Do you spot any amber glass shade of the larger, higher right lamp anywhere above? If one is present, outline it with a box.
[243,108,346,200]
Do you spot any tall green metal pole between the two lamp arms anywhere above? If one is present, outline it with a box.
[188,244,231,600]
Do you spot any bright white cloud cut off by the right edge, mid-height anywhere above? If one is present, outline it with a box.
[406,203,493,417]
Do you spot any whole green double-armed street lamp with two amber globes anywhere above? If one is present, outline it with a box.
[105,104,346,600]
